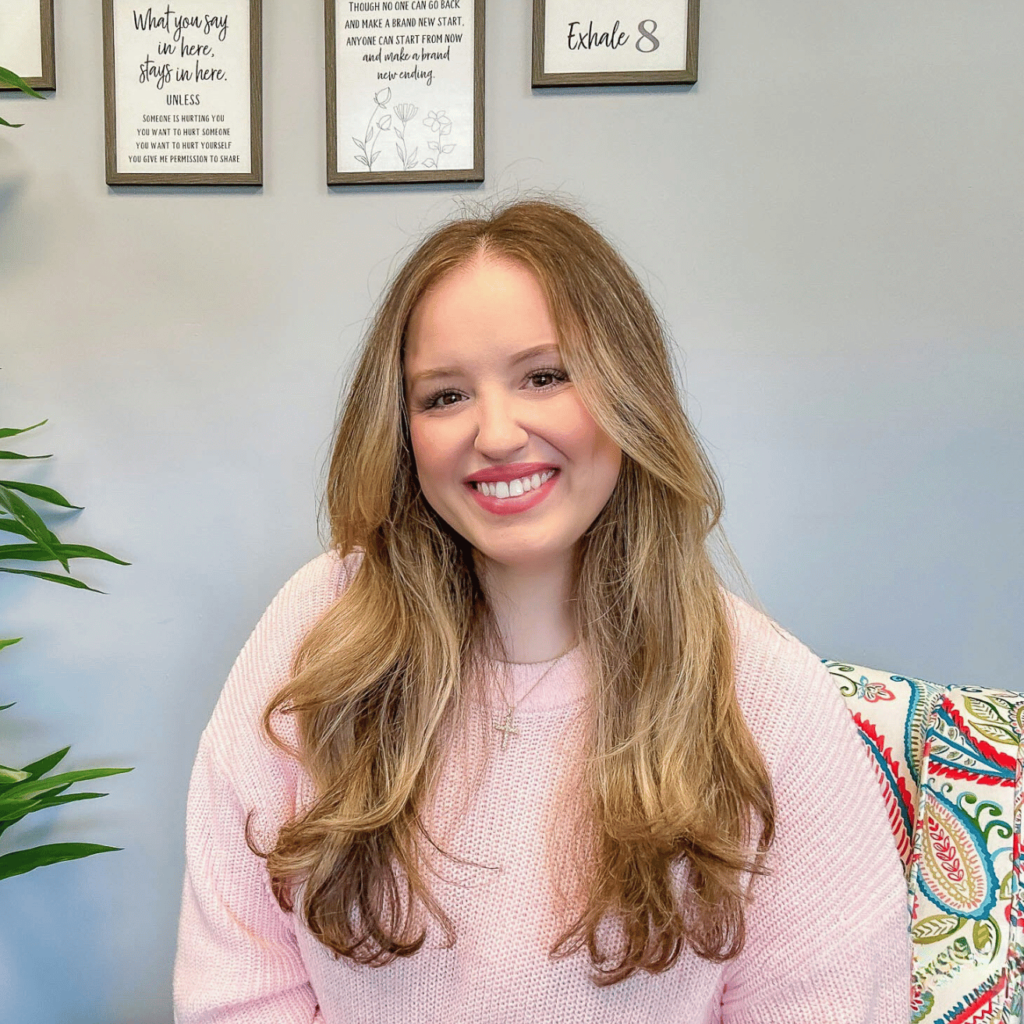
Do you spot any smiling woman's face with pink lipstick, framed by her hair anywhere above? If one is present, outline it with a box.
[403,257,622,569]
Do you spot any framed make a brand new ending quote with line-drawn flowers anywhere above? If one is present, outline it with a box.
[325,0,484,185]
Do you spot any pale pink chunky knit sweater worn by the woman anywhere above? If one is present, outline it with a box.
[174,553,910,1024]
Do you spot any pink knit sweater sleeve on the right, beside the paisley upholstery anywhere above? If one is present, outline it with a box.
[722,602,911,1024]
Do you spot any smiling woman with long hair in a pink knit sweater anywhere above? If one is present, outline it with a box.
[169,202,910,1024]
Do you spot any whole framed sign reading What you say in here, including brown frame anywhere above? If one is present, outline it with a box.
[103,0,263,185]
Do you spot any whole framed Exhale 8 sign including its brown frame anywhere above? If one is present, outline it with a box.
[534,0,698,88]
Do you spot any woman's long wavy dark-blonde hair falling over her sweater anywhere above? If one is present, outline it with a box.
[263,201,775,984]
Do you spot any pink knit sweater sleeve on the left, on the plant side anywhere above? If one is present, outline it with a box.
[174,553,358,1024]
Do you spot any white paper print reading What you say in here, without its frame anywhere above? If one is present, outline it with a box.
[114,0,252,174]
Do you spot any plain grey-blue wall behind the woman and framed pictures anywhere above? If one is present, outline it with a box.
[0,0,1024,1024]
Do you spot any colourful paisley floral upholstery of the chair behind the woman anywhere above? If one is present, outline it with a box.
[824,660,1024,1024]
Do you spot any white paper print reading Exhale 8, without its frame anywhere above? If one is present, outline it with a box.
[544,0,689,75]
